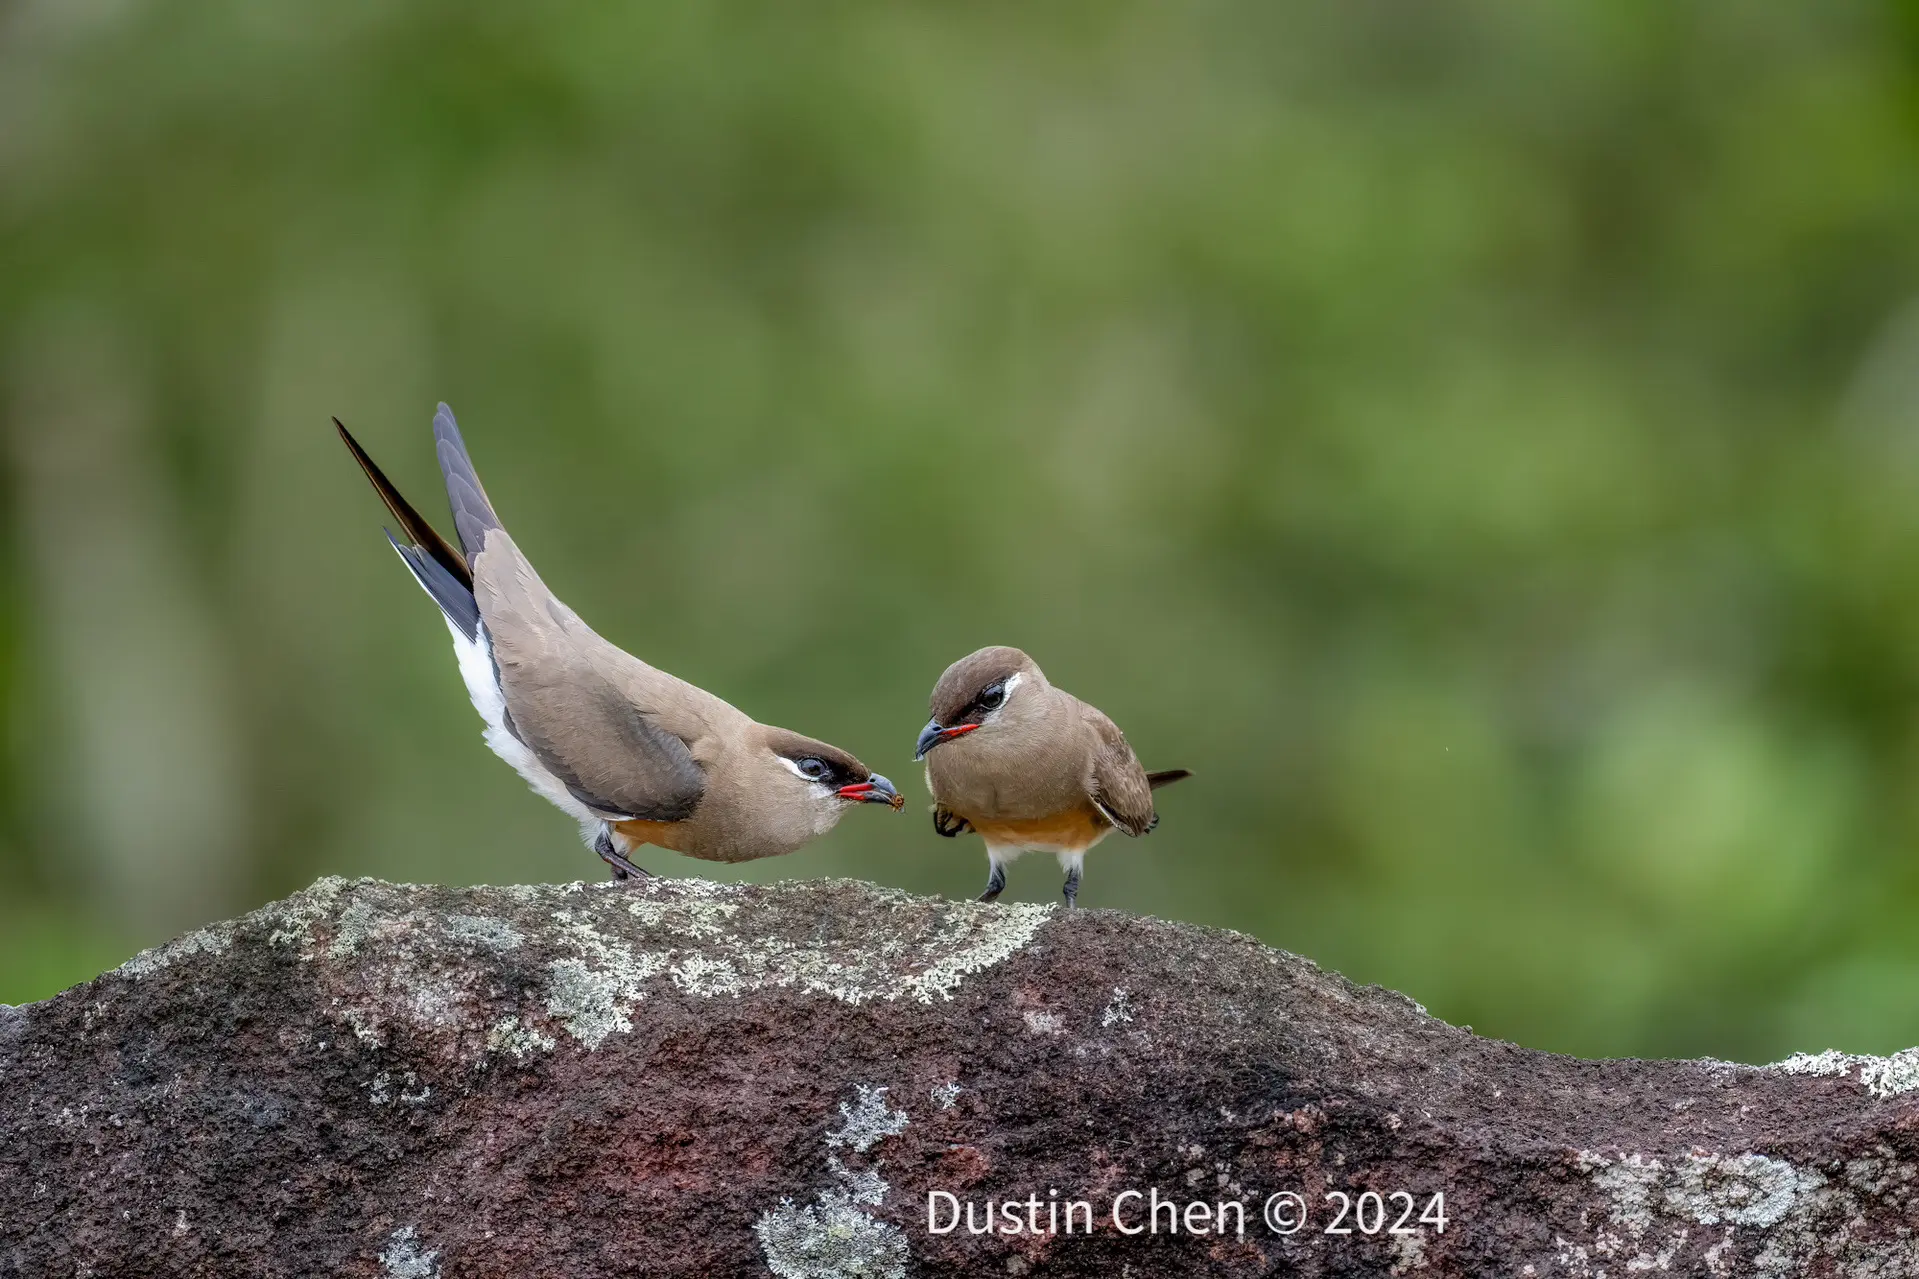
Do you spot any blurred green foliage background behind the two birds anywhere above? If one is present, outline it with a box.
[0,0,1919,1060]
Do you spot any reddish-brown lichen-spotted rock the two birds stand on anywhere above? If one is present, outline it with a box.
[0,880,1919,1279]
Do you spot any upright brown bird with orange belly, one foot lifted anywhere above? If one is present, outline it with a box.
[913,647,1192,908]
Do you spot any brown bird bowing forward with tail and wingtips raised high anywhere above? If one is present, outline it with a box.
[334,405,906,880]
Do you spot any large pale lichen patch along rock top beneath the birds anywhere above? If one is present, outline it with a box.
[206,878,1054,1058]
